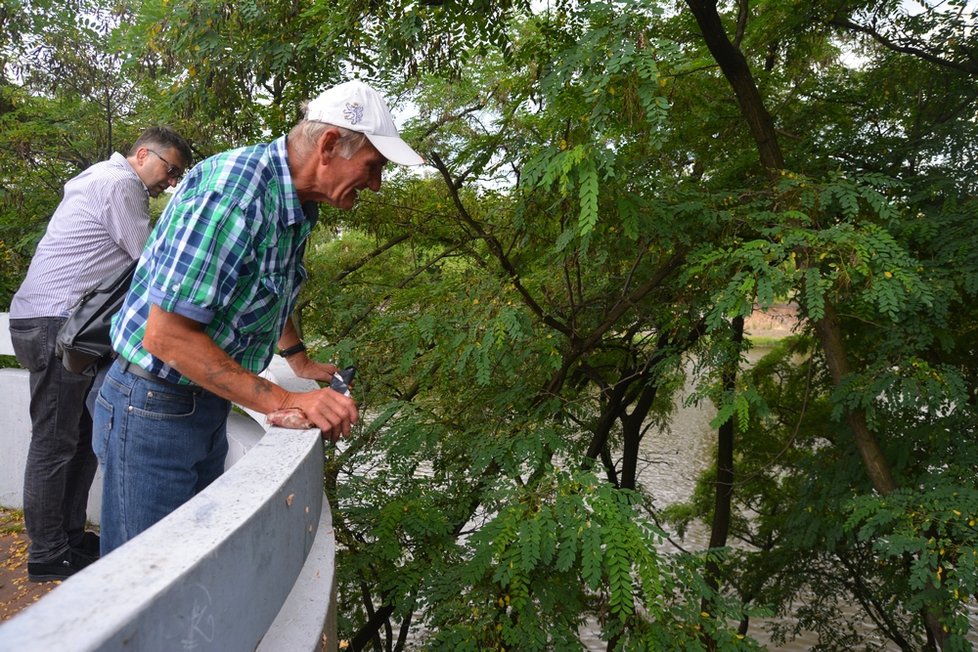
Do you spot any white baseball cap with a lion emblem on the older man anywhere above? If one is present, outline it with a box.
[306,80,424,165]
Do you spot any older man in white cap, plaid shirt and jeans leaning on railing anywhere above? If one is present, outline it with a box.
[94,81,422,555]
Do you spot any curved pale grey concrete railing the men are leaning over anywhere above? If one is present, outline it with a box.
[0,314,336,652]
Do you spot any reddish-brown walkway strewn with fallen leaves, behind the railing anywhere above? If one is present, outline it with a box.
[0,507,61,621]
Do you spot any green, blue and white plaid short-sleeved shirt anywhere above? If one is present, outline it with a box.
[112,136,311,384]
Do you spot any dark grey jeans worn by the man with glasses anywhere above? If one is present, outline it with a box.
[10,317,98,563]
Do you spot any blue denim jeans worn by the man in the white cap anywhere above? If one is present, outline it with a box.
[93,358,231,555]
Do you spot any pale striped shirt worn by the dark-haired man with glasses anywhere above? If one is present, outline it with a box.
[10,153,149,319]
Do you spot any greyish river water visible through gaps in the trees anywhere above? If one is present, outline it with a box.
[581,348,978,652]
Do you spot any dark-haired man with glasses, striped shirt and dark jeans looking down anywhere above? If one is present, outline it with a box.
[10,127,193,582]
